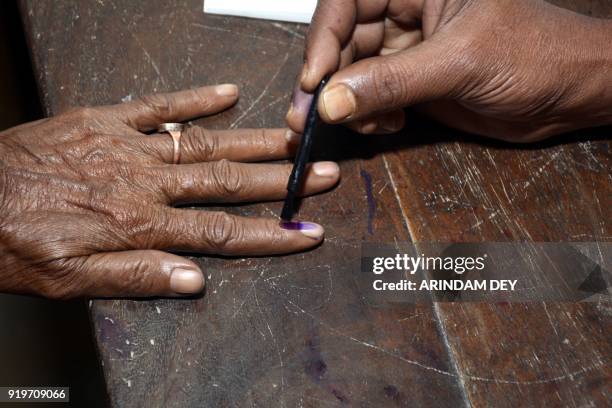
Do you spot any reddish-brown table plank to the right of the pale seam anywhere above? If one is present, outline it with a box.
[385,1,612,406]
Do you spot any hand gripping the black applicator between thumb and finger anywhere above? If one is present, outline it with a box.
[287,0,612,142]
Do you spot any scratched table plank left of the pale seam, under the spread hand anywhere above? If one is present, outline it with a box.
[23,0,466,407]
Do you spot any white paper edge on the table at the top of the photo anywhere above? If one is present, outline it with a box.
[204,0,317,23]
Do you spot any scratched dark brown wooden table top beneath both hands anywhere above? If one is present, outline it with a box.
[21,0,612,407]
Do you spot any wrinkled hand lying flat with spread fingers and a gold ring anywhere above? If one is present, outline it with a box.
[0,85,339,298]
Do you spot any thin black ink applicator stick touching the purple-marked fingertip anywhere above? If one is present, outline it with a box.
[281,77,327,224]
